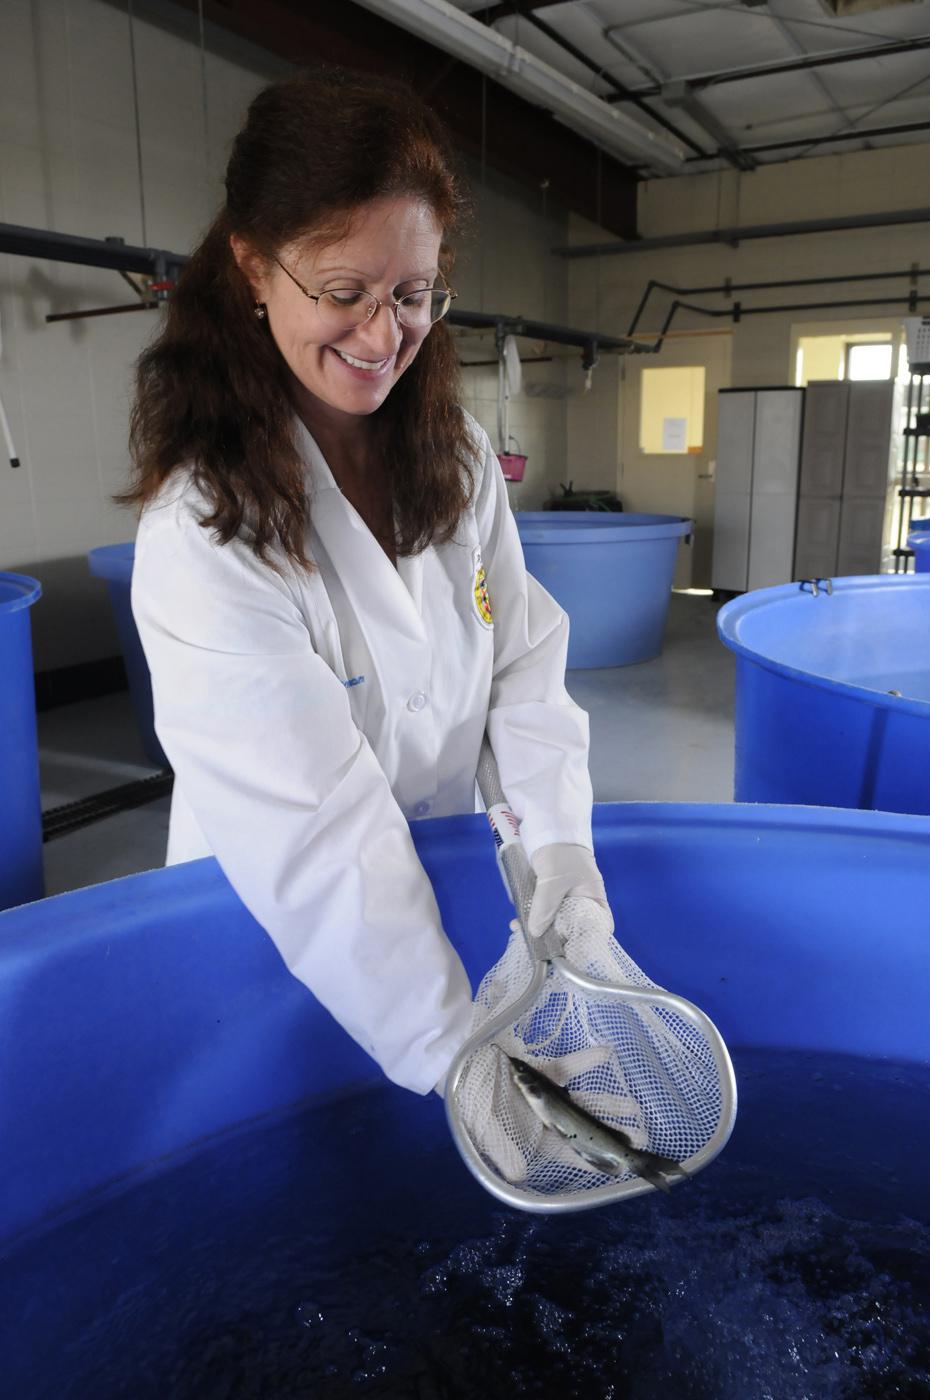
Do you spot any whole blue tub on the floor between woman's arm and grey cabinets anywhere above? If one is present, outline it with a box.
[517,511,692,669]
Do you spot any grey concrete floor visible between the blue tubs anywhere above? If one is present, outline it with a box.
[39,594,734,895]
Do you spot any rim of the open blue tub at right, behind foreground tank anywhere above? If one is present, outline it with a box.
[717,574,930,720]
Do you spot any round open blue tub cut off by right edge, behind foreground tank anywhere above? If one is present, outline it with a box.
[717,574,930,813]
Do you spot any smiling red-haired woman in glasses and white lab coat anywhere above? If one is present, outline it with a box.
[126,65,606,1114]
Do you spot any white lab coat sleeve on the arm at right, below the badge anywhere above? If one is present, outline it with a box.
[475,430,592,855]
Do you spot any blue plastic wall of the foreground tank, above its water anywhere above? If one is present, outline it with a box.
[0,804,930,1254]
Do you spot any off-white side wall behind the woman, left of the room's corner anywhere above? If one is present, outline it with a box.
[0,0,570,671]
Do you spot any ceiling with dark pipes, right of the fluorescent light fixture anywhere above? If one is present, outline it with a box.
[442,0,930,175]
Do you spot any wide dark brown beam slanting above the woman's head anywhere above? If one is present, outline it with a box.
[161,0,637,238]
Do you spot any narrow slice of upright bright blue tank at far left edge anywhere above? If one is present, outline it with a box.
[0,574,45,909]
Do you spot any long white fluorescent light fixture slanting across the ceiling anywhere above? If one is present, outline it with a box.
[348,0,685,172]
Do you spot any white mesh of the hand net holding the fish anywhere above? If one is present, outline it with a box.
[455,899,721,1196]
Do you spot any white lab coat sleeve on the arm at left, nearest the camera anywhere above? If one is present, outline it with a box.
[133,504,472,1093]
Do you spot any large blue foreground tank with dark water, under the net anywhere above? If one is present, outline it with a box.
[0,804,930,1400]
